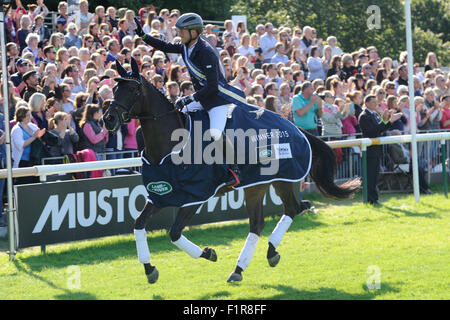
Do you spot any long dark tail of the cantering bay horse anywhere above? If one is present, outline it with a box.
[300,129,361,199]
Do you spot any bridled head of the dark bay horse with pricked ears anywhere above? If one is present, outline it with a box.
[103,58,142,132]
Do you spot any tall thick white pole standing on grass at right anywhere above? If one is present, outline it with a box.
[405,0,420,202]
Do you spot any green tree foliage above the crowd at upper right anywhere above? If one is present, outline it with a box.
[231,0,450,65]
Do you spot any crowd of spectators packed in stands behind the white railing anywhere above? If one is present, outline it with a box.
[0,0,450,215]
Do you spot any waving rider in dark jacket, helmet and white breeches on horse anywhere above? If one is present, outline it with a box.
[135,13,245,187]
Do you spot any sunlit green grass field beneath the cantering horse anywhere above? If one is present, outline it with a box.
[0,189,450,300]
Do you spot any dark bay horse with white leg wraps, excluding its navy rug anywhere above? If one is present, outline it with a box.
[103,59,361,283]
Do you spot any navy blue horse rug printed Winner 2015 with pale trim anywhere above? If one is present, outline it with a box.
[142,105,312,208]
